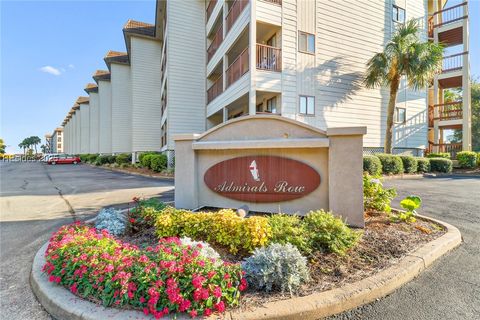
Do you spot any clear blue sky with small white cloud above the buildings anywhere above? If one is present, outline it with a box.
[0,0,480,152]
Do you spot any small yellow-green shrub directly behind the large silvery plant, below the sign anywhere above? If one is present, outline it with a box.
[268,214,311,254]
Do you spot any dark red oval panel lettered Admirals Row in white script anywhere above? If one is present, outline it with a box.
[204,156,320,203]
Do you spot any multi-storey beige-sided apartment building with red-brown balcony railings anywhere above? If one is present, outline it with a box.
[58,0,471,159]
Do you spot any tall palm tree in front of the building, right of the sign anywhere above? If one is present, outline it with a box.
[364,20,443,153]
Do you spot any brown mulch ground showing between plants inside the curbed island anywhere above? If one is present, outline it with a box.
[117,214,445,310]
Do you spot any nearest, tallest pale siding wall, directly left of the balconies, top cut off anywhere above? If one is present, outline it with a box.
[167,0,206,148]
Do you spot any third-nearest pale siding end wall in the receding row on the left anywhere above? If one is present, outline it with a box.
[110,64,132,153]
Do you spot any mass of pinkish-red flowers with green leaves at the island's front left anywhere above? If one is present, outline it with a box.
[43,224,246,318]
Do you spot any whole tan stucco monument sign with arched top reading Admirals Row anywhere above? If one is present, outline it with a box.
[174,115,366,227]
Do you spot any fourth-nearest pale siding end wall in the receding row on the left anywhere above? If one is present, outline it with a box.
[98,81,112,153]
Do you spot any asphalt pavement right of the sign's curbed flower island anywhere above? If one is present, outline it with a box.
[330,176,480,320]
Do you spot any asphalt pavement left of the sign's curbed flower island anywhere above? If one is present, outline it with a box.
[0,162,173,320]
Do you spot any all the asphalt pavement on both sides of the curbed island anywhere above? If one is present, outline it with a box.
[0,163,480,320]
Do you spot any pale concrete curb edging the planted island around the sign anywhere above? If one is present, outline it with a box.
[30,216,462,320]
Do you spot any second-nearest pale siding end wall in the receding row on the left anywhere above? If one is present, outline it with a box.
[130,37,162,151]
